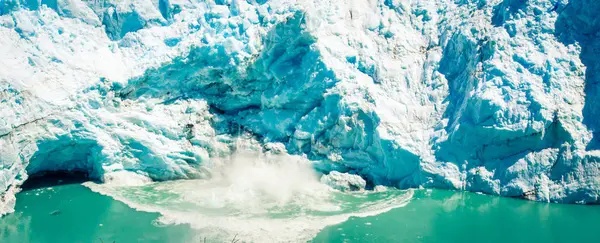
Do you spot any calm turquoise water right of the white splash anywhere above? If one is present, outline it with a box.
[314,190,600,243]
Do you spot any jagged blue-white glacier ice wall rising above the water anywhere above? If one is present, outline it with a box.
[0,0,600,213]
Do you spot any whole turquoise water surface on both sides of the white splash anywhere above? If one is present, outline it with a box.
[0,178,600,243]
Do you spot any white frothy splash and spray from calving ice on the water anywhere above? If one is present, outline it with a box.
[85,139,413,242]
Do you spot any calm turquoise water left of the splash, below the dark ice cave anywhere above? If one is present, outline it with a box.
[0,178,194,243]
